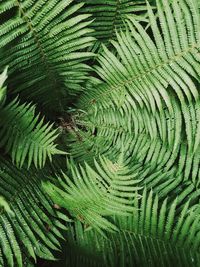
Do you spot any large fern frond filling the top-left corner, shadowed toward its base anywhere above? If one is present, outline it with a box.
[0,0,94,112]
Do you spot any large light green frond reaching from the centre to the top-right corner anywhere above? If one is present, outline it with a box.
[79,0,200,113]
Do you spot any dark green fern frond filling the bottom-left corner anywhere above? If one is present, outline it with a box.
[0,156,67,267]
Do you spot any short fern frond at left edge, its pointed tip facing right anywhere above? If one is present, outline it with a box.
[0,98,66,168]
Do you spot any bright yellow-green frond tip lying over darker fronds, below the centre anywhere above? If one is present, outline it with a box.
[43,157,140,233]
